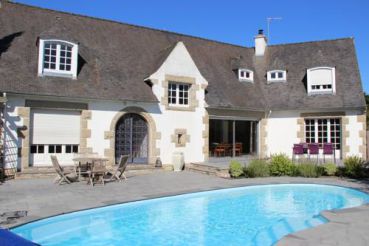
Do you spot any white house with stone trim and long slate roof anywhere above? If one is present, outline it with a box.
[0,1,366,175]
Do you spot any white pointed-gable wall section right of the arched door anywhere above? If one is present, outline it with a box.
[150,42,208,164]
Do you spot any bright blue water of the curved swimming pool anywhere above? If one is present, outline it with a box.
[12,184,369,246]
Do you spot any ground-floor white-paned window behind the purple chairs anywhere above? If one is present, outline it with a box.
[305,118,341,149]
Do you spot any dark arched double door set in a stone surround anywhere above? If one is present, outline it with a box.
[115,114,149,164]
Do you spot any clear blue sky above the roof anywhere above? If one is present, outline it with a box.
[15,0,369,93]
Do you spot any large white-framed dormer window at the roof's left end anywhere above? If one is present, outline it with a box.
[38,39,78,79]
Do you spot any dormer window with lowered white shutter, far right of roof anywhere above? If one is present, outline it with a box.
[307,67,336,95]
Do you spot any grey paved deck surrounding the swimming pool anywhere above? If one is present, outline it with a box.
[0,171,369,245]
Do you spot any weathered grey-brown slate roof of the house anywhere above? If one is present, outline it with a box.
[0,2,365,111]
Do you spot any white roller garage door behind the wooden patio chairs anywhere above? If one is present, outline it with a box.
[30,109,81,166]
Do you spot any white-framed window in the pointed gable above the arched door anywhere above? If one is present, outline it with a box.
[168,82,190,106]
